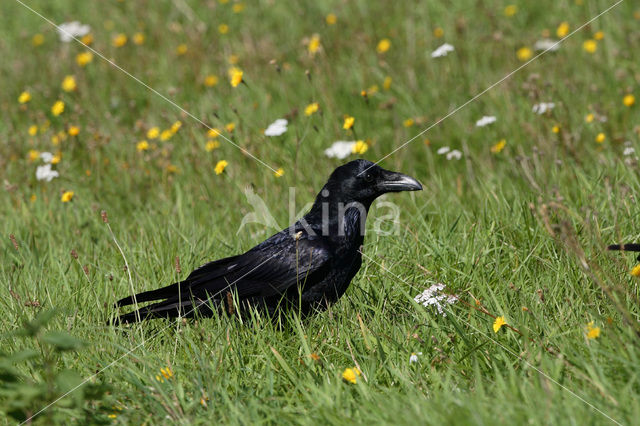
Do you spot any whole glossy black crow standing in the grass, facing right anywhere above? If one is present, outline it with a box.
[117,160,422,322]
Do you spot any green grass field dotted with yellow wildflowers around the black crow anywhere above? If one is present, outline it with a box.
[0,0,640,425]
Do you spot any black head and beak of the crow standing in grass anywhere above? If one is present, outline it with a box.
[322,159,422,205]
